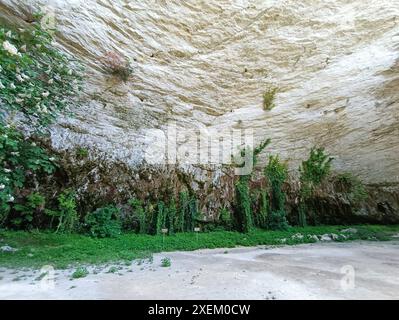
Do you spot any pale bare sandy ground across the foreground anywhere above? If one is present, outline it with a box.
[0,241,399,299]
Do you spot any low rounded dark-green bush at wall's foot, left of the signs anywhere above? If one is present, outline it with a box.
[85,206,121,238]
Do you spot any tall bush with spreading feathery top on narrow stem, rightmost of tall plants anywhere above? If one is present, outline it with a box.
[299,147,333,226]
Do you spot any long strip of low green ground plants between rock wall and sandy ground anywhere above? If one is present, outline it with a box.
[0,225,399,268]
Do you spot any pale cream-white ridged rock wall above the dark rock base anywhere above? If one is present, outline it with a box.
[0,0,399,183]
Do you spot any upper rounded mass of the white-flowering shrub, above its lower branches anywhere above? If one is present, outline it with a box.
[0,14,82,127]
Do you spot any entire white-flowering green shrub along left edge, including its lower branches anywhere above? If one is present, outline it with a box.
[0,14,82,229]
